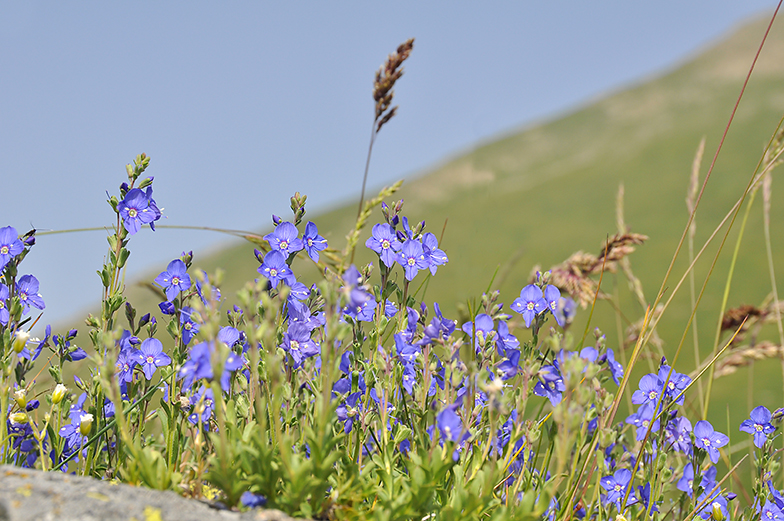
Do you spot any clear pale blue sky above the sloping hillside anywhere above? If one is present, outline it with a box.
[0,0,781,323]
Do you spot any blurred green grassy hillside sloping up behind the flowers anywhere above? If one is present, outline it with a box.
[115,14,784,421]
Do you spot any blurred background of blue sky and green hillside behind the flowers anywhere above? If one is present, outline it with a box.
[0,0,784,420]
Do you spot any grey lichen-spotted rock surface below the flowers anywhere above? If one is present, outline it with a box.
[0,465,302,521]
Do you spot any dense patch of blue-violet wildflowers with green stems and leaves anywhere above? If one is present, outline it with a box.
[0,156,784,521]
